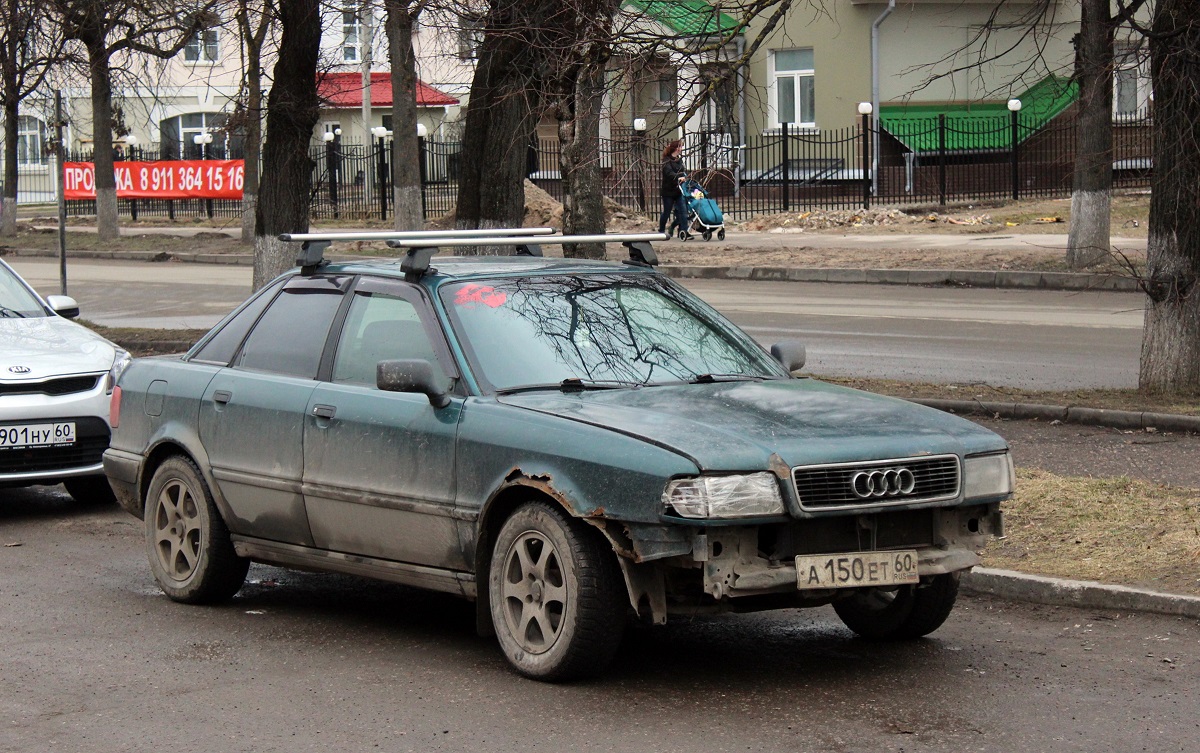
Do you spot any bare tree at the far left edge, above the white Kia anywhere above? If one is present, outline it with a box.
[0,0,62,235]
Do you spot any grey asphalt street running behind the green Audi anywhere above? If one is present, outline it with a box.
[13,259,1144,390]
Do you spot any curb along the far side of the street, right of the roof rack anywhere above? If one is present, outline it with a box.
[661,264,1140,293]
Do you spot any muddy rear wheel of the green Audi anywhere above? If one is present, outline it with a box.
[145,456,250,604]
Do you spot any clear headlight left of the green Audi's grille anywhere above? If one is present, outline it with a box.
[662,472,785,518]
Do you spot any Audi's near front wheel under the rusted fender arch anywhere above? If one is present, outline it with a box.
[487,502,626,682]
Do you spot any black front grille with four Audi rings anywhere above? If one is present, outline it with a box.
[792,454,959,510]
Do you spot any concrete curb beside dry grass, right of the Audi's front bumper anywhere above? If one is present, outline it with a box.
[961,567,1200,620]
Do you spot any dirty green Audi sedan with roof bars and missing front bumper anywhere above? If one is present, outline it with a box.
[104,236,1013,680]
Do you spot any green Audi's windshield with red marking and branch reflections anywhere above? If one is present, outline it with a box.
[442,275,787,391]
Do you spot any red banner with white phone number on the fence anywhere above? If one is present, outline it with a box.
[62,159,246,199]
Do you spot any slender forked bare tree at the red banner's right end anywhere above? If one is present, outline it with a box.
[230,0,277,243]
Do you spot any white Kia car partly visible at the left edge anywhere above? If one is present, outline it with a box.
[0,260,130,502]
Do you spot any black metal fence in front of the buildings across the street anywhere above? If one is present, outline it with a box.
[4,107,1153,222]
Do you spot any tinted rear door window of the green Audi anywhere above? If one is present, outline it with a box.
[234,285,343,379]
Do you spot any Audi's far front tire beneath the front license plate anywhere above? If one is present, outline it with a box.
[833,573,959,640]
